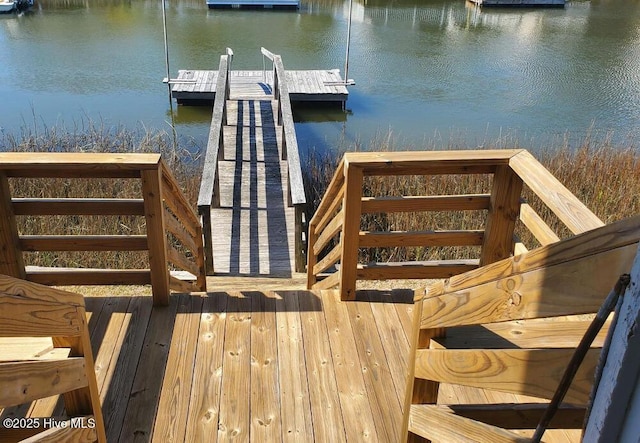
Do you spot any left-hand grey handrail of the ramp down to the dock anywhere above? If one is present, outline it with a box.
[198,48,233,275]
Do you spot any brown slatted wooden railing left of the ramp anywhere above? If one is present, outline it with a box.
[0,153,206,305]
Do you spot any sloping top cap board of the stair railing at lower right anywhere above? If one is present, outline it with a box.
[428,216,640,296]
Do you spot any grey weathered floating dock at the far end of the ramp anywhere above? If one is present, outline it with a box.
[171,69,349,104]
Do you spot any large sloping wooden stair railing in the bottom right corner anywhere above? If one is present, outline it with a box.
[402,217,640,443]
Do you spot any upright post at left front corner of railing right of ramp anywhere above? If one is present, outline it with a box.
[340,163,363,300]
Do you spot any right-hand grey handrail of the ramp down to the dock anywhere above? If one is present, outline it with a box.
[260,48,307,272]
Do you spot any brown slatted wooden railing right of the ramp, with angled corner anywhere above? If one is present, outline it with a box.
[307,150,603,300]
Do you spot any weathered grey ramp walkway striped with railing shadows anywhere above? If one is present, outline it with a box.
[211,100,295,276]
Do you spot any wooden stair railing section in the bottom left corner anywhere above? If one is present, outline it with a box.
[0,275,106,442]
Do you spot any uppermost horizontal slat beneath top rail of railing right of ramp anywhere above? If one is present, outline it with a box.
[362,194,490,214]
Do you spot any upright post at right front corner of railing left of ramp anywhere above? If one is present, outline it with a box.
[140,163,169,306]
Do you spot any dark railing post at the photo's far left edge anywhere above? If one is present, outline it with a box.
[0,172,26,279]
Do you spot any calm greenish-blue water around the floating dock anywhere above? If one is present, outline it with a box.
[0,0,640,154]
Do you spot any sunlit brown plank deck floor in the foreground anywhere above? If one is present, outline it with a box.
[0,286,580,443]
